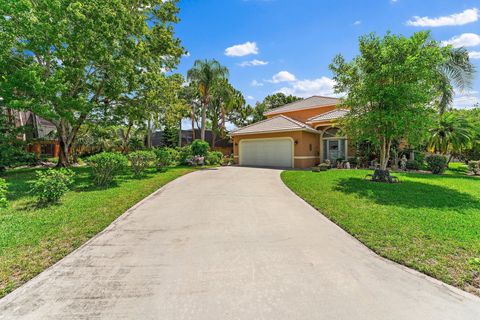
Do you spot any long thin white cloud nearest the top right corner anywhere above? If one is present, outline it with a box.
[407,8,480,27]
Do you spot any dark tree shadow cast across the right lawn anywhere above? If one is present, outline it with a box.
[334,178,480,209]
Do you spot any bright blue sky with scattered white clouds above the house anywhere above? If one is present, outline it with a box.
[176,0,480,107]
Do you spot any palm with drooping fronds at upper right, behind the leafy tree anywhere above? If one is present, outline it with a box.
[437,48,475,114]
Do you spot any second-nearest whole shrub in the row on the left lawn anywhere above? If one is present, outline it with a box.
[87,152,128,186]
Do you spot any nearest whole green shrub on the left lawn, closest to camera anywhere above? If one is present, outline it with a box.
[32,168,74,204]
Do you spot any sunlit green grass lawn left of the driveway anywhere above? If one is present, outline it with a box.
[0,167,194,298]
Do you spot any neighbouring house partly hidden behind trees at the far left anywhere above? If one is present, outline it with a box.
[9,110,60,157]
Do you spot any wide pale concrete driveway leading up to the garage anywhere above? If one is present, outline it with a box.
[0,167,480,320]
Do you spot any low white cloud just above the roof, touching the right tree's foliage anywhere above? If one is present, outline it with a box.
[278,77,335,98]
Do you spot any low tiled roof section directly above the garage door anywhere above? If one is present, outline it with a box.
[231,115,318,136]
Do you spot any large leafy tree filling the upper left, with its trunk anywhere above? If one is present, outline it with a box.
[0,0,183,166]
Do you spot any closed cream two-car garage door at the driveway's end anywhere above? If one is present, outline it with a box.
[239,139,293,168]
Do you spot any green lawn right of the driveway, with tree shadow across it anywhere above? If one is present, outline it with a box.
[282,168,480,295]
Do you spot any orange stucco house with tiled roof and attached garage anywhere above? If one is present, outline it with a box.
[230,96,354,168]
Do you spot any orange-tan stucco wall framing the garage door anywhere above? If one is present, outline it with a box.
[233,131,320,168]
